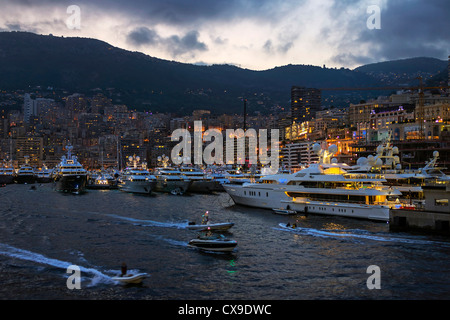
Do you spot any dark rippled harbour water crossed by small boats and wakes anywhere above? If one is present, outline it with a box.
[0,184,450,300]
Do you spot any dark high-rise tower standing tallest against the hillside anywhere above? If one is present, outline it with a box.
[291,86,322,123]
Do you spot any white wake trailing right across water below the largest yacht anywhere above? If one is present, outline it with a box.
[274,223,450,247]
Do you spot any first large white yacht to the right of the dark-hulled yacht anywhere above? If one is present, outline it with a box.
[118,156,156,194]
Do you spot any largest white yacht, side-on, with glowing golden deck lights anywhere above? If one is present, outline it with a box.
[224,144,401,221]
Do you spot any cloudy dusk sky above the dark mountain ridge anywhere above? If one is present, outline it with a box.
[0,0,450,70]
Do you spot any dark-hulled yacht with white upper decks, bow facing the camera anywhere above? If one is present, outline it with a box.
[54,145,87,194]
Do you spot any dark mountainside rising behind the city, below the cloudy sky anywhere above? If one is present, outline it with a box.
[0,32,442,114]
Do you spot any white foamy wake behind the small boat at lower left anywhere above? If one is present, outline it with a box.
[0,243,115,287]
